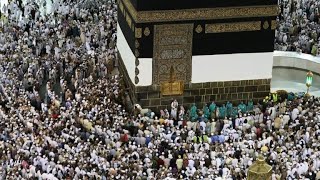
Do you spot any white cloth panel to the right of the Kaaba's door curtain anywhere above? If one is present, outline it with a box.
[192,52,273,83]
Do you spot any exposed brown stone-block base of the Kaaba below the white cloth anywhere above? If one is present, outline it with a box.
[135,79,271,111]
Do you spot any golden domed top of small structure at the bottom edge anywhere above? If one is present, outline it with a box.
[248,155,272,180]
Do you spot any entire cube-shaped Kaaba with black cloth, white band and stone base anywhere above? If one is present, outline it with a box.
[117,0,279,110]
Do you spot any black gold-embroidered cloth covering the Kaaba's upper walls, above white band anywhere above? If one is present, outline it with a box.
[118,0,278,58]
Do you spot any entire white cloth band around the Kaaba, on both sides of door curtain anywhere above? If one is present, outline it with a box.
[118,30,273,86]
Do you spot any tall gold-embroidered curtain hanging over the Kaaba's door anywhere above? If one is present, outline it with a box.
[152,24,193,84]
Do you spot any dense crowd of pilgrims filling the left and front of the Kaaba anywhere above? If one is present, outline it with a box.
[0,0,320,180]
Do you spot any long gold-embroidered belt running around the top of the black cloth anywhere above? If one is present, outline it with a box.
[119,0,279,23]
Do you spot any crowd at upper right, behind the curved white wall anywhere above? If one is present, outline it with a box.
[275,0,320,56]
